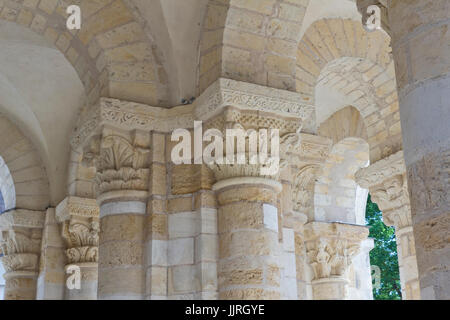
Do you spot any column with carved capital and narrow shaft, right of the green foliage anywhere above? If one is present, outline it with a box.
[355,151,420,300]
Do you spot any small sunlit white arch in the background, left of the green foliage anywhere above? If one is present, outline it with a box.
[311,106,369,225]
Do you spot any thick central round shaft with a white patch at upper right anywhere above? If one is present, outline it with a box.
[216,178,281,300]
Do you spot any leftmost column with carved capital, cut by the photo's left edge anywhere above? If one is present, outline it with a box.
[0,210,45,300]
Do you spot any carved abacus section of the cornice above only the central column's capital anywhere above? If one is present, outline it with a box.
[195,78,315,132]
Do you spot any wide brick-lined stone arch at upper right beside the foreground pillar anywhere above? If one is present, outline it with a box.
[296,19,402,162]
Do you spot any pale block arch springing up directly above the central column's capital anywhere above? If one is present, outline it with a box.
[197,0,309,94]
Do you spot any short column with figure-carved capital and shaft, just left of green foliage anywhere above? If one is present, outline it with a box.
[305,222,369,300]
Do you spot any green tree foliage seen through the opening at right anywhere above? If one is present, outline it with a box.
[366,195,402,300]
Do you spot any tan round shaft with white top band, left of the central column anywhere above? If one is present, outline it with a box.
[98,190,147,300]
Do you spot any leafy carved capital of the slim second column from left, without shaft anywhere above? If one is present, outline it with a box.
[56,197,100,264]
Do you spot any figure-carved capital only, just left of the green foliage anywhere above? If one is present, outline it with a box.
[304,222,369,280]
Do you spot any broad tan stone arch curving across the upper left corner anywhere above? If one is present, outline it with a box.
[0,0,168,106]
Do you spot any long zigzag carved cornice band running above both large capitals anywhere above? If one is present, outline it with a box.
[70,78,315,150]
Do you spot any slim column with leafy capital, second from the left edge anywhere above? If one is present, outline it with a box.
[56,197,99,300]
